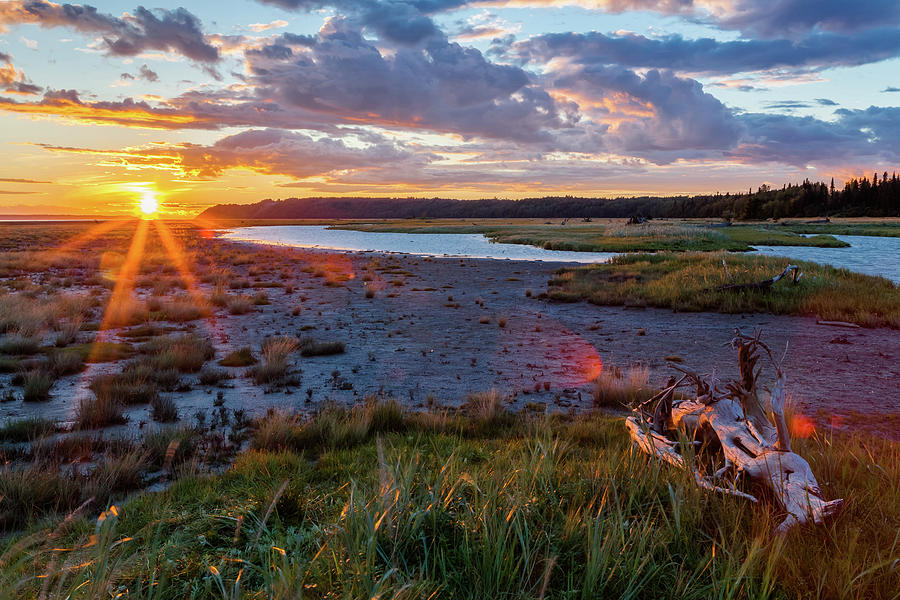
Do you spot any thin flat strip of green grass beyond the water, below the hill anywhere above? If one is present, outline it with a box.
[333,219,848,252]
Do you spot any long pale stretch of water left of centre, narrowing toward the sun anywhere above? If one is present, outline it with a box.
[222,225,616,263]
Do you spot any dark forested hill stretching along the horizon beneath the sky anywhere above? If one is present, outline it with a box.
[198,173,900,219]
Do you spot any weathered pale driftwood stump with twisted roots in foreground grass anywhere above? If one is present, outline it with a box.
[625,332,843,533]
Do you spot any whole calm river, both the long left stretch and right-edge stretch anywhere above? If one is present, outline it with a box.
[223,225,900,283]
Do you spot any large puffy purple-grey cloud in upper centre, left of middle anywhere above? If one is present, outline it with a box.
[247,18,568,141]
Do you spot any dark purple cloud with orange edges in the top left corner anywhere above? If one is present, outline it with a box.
[0,0,219,64]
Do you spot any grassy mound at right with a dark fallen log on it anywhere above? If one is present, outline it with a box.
[547,253,900,328]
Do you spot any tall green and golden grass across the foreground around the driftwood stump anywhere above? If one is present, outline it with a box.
[0,408,900,600]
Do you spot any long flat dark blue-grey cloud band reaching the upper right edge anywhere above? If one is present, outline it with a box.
[511,28,900,75]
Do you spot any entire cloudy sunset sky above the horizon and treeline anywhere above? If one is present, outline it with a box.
[0,0,900,216]
